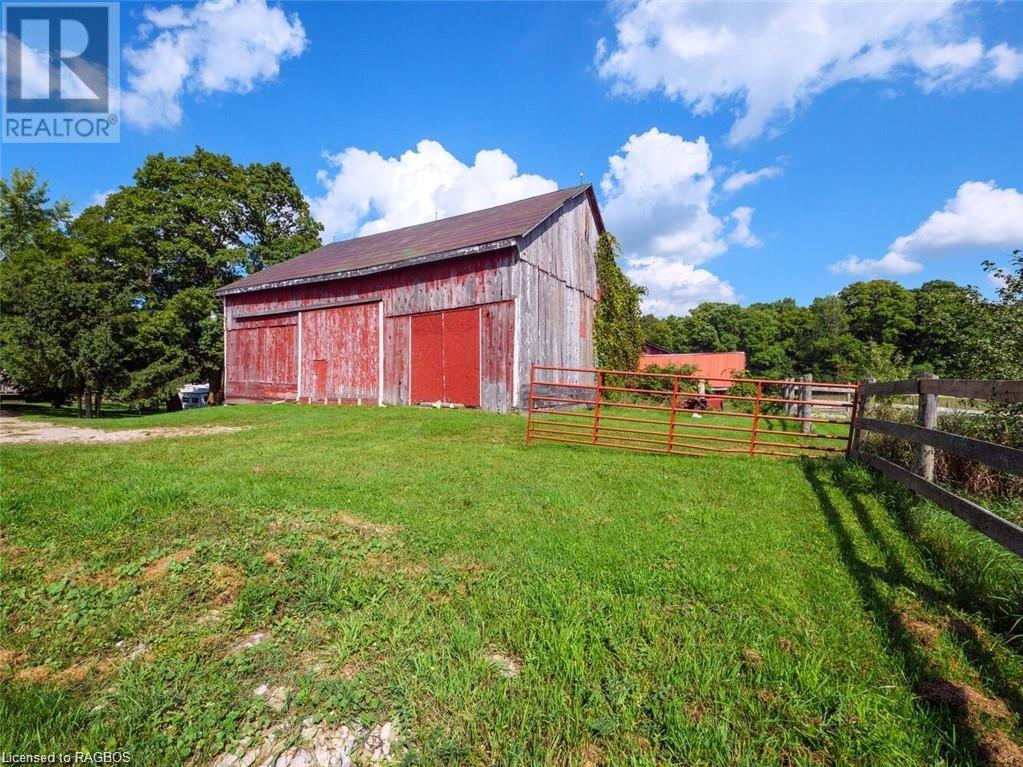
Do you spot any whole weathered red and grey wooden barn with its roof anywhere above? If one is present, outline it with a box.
[212,184,604,412]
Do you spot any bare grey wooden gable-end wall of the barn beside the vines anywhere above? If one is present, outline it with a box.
[516,195,599,407]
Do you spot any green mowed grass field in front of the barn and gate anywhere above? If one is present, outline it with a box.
[0,405,1023,766]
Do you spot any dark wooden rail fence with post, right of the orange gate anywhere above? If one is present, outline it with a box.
[849,376,1023,556]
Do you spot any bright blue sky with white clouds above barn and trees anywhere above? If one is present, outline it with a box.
[2,0,1023,314]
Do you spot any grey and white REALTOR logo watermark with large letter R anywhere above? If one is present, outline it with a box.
[0,2,121,143]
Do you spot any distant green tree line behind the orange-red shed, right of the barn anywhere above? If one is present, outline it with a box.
[639,267,1023,380]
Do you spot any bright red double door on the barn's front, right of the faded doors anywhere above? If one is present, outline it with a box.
[412,307,480,407]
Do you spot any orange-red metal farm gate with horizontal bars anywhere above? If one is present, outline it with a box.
[526,365,859,457]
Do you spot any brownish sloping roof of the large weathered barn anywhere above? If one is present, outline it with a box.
[217,184,604,296]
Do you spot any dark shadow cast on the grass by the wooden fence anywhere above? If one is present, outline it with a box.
[803,460,1023,763]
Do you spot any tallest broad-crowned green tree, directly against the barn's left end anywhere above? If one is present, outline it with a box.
[72,147,322,406]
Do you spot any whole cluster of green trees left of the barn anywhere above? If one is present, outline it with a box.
[0,147,322,415]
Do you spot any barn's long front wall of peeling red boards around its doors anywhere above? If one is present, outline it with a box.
[219,249,517,411]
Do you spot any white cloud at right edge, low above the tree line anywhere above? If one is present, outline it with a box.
[831,181,1023,275]
